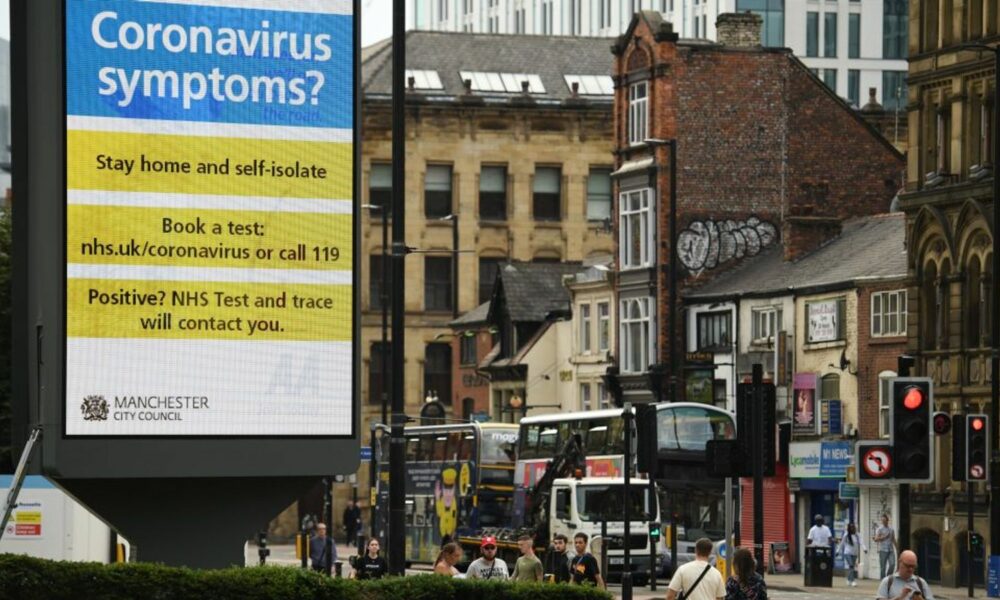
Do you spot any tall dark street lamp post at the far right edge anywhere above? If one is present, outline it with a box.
[958,44,1000,578]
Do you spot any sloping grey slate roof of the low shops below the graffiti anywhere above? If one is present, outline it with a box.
[684,213,907,300]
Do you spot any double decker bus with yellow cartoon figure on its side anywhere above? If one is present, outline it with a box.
[374,422,518,563]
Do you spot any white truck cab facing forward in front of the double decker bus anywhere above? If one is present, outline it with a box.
[549,477,660,583]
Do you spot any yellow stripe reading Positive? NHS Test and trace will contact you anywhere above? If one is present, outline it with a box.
[66,279,352,342]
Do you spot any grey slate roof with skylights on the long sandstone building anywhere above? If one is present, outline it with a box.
[361,31,615,107]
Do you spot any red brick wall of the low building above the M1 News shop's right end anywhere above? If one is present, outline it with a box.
[850,282,906,440]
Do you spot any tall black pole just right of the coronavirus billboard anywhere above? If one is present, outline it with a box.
[388,0,406,576]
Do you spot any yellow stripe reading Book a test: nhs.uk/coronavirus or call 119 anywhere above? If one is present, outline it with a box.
[67,204,353,271]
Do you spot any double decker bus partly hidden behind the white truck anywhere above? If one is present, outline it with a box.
[514,402,736,562]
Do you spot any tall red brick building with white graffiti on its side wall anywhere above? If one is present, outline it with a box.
[613,11,903,407]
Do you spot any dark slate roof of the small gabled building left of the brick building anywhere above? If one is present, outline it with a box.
[490,261,585,323]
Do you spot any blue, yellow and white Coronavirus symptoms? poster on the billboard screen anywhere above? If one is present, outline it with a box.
[65,0,355,437]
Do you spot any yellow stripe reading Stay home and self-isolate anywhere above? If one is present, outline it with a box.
[66,130,353,198]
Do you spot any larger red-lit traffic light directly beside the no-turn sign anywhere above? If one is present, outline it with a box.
[891,377,934,483]
